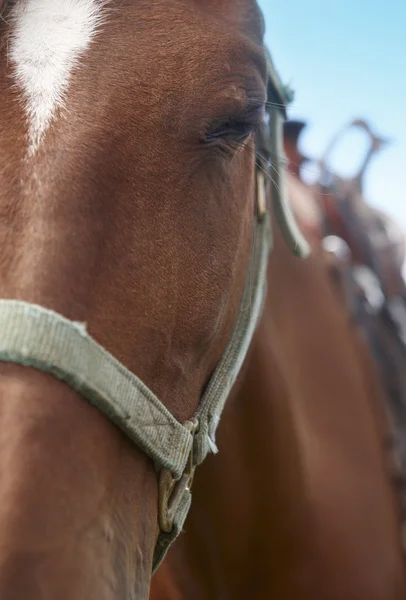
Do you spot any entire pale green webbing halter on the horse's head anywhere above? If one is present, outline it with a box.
[0,49,308,570]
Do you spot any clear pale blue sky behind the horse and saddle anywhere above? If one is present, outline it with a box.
[258,0,406,231]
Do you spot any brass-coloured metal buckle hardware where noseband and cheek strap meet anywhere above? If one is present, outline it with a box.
[158,418,199,533]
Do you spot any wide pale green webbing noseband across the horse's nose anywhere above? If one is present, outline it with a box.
[0,300,192,478]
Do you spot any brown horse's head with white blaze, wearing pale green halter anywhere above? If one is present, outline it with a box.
[0,0,294,600]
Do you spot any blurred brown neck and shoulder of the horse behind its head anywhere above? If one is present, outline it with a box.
[151,162,406,600]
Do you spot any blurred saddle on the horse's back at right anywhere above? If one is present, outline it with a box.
[302,119,406,547]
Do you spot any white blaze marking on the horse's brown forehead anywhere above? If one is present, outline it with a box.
[9,0,106,155]
